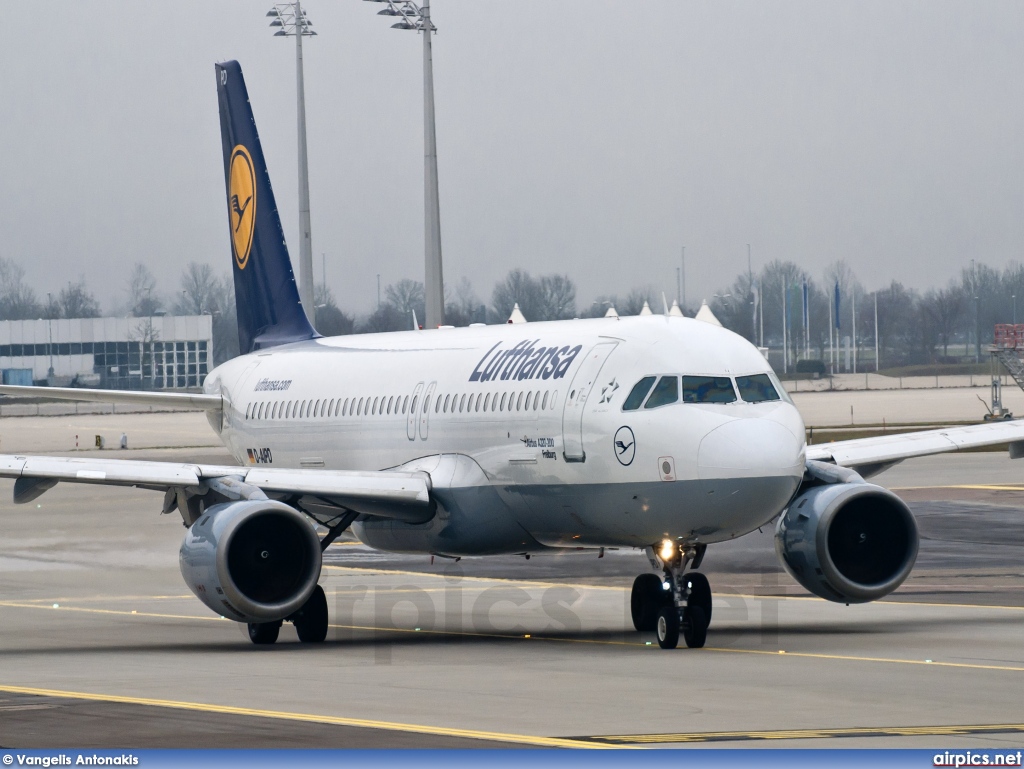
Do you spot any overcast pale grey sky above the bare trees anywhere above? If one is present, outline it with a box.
[0,0,1024,312]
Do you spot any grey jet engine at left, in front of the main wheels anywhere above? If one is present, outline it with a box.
[178,500,323,623]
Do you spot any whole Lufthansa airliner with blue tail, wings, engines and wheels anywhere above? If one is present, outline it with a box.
[0,61,1024,648]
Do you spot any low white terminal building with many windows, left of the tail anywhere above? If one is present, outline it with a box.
[0,315,213,390]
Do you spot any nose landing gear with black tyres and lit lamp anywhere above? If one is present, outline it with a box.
[630,541,712,649]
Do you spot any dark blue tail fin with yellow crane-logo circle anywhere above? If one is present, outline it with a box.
[216,61,317,353]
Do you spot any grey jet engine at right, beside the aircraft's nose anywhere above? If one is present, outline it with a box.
[775,482,919,603]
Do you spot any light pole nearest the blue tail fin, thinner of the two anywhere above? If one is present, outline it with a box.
[266,0,316,323]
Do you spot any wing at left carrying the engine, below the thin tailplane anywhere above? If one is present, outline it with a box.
[0,455,432,519]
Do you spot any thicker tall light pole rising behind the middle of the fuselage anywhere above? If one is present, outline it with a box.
[370,0,444,329]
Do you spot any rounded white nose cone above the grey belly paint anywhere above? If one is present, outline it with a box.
[697,419,804,478]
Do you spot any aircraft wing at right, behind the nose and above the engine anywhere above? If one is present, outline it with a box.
[807,420,1024,477]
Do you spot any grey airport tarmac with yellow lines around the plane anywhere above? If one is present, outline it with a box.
[0,405,1024,749]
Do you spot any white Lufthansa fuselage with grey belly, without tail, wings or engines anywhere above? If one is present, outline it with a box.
[206,315,805,555]
